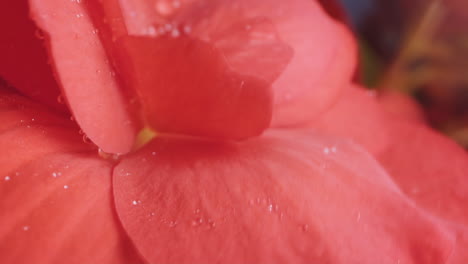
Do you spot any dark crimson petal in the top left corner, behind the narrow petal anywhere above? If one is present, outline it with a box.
[0,0,67,112]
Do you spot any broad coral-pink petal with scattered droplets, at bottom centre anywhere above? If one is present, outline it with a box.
[114,131,452,264]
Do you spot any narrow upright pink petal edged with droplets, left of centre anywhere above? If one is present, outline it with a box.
[30,0,136,153]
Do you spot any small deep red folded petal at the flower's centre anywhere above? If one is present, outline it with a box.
[119,37,272,139]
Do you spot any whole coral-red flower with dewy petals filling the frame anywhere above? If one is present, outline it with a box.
[0,0,468,263]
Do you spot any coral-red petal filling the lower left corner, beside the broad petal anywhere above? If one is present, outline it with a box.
[0,91,142,264]
